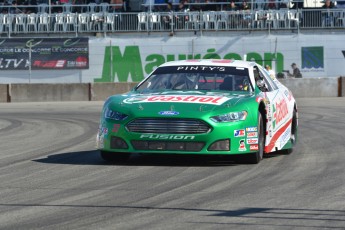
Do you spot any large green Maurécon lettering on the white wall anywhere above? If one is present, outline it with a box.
[95,44,285,82]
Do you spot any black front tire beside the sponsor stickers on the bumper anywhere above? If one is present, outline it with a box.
[243,112,265,164]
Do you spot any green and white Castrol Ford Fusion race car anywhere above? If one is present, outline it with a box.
[97,60,298,163]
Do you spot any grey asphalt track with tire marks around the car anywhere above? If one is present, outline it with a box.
[0,98,345,230]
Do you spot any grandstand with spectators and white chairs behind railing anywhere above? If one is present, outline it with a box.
[0,0,345,37]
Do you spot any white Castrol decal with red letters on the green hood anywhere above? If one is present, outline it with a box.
[123,95,229,105]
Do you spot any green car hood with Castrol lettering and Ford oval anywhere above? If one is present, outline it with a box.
[106,91,255,118]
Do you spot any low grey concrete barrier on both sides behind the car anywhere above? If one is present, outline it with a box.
[0,77,345,102]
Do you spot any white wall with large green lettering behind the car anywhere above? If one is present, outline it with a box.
[0,33,345,84]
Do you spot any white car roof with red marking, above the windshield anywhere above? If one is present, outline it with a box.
[160,59,255,68]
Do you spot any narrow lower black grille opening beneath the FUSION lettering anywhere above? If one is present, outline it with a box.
[131,141,205,152]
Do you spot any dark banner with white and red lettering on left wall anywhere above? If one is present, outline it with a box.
[0,38,89,70]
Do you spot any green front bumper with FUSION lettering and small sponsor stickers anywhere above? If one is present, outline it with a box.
[97,120,258,155]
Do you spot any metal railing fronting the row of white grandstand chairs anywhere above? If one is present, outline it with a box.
[0,6,345,37]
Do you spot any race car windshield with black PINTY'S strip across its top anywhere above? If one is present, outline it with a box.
[136,66,252,93]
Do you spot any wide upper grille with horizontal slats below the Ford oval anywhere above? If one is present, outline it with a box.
[126,118,211,134]
